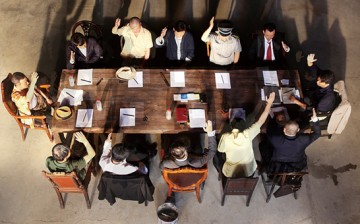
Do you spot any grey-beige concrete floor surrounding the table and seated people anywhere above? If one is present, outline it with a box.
[0,0,360,224]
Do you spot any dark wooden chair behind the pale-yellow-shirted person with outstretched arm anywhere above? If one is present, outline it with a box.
[220,171,259,207]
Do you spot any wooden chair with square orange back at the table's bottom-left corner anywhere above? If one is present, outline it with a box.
[42,162,93,209]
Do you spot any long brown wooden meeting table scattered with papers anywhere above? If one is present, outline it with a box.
[51,69,301,141]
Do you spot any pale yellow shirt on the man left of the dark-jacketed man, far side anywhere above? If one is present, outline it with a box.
[112,26,153,58]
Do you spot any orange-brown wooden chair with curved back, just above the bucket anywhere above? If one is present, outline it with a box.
[162,166,208,203]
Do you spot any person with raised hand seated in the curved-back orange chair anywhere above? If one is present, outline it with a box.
[160,121,217,169]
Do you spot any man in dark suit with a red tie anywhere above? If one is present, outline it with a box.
[249,23,290,66]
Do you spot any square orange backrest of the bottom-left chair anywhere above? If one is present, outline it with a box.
[42,171,85,192]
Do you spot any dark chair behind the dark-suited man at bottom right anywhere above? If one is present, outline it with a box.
[261,172,308,202]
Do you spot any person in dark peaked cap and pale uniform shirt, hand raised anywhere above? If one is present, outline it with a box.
[201,17,242,65]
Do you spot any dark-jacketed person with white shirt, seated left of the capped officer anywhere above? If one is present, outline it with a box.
[155,20,195,61]
